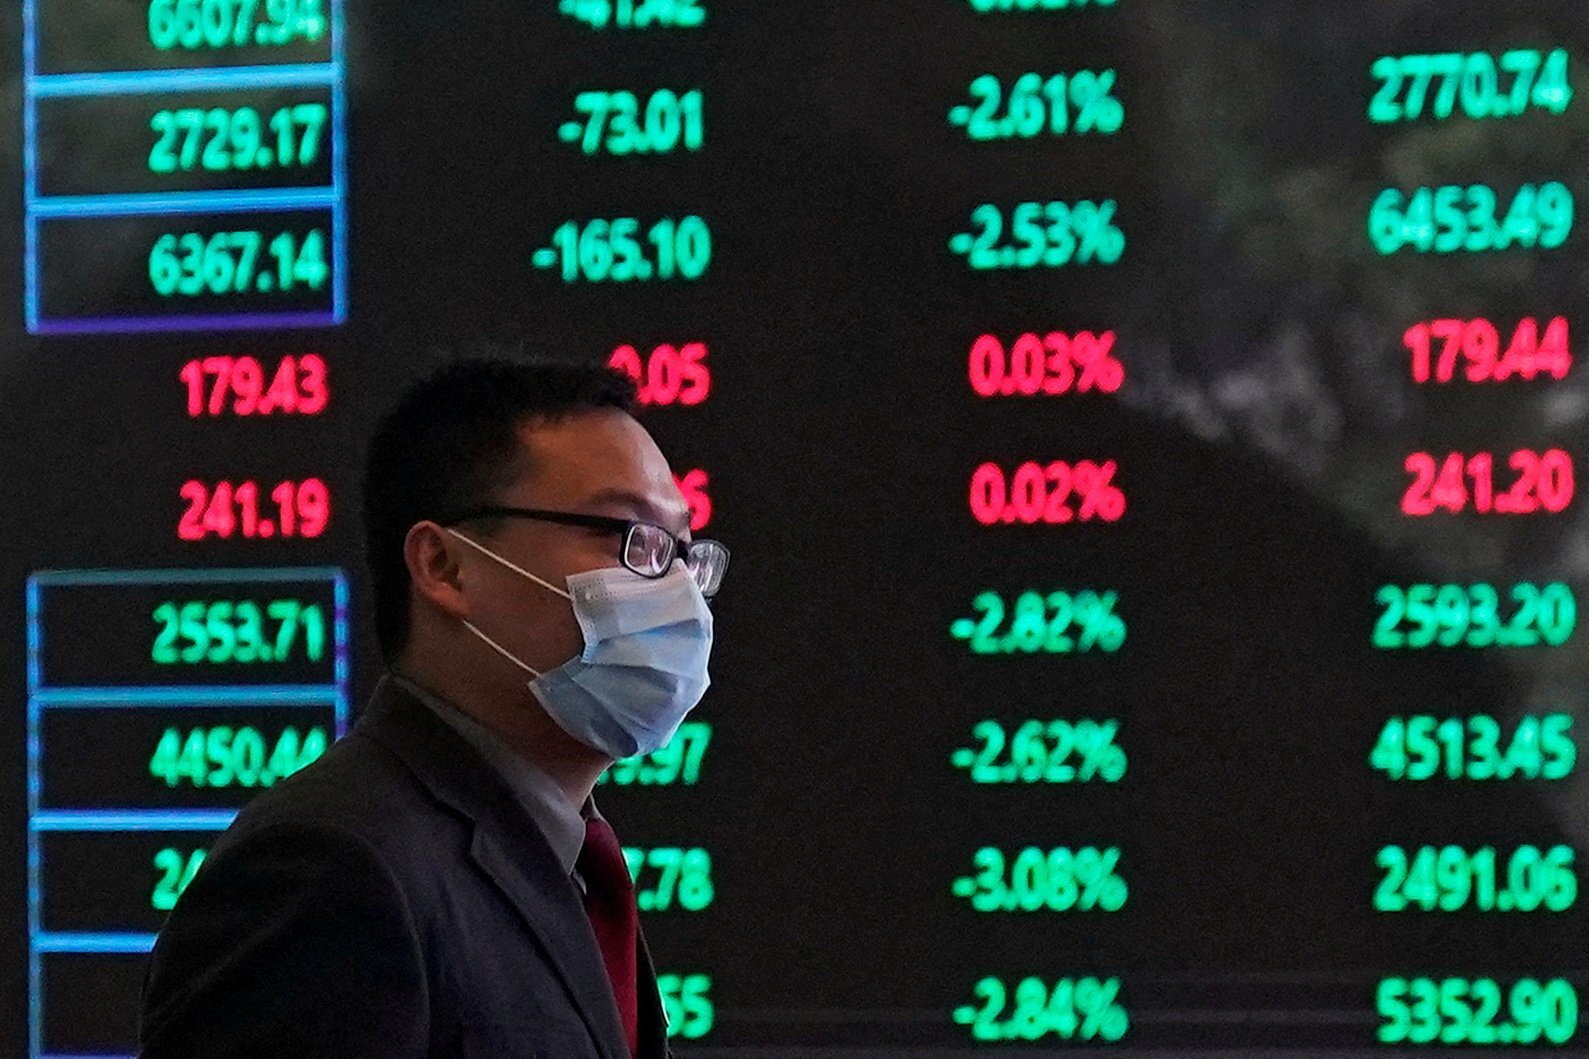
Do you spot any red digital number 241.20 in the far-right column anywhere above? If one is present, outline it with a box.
[1401,448,1573,518]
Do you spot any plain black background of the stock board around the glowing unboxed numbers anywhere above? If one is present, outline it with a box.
[0,0,1589,1056]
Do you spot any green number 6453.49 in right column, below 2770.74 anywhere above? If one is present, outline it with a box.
[1368,181,1575,256]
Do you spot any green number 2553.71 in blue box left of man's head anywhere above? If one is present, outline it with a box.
[149,599,326,666]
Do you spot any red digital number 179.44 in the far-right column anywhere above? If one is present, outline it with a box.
[1401,316,1573,383]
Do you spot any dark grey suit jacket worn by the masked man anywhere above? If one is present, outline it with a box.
[140,681,669,1059]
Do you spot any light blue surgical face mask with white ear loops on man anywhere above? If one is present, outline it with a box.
[448,530,712,758]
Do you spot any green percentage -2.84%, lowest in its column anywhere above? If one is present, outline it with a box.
[953,976,1131,1042]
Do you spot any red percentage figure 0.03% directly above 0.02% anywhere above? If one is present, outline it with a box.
[969,331,1125,398]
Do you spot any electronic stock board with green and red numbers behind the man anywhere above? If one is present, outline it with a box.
[0,0,1589,1059]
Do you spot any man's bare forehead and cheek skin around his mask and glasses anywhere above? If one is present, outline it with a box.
[453,409,690,676]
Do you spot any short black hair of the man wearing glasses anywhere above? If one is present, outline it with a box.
[364,355,636,663]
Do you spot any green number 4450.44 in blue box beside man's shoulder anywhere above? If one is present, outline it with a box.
[149,725,327,789]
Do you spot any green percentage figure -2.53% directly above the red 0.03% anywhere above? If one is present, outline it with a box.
[949,199,1125,272]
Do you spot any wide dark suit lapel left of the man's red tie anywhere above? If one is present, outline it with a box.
[358,681,632,1059]
